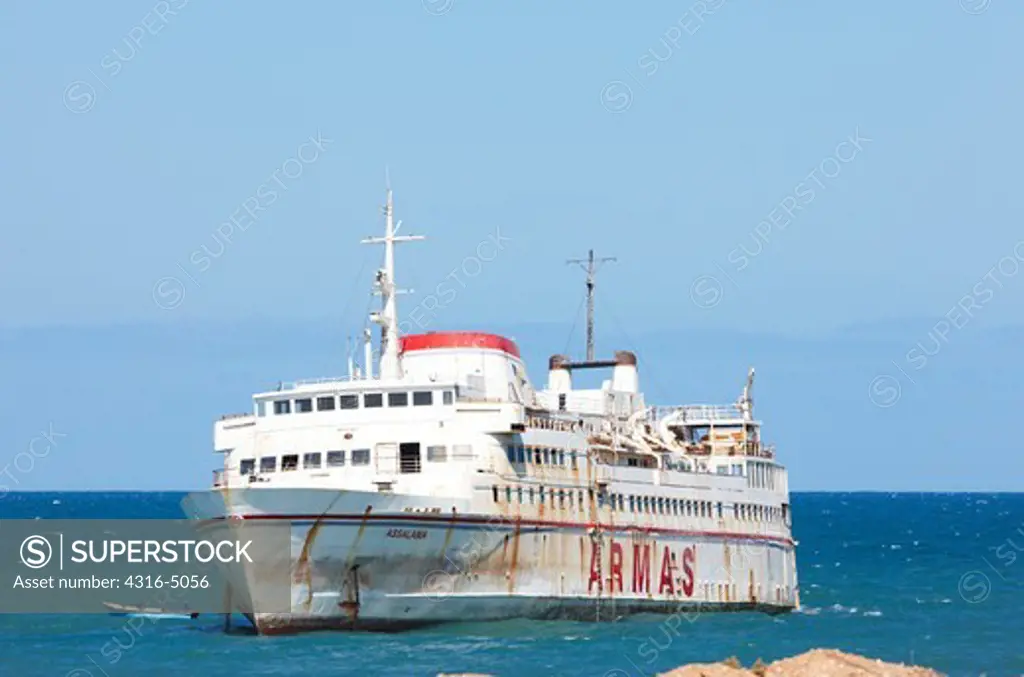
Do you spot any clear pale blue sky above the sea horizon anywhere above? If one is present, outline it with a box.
[0,0,1024,485]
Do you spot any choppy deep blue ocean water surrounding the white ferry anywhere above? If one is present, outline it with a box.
[0,493,1024,677]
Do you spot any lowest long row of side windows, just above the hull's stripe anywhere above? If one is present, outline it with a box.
[490,485,783,521]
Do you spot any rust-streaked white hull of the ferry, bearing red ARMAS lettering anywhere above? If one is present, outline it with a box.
[184,490,797,634]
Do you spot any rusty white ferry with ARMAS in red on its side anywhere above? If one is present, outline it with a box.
[184,186,799,634]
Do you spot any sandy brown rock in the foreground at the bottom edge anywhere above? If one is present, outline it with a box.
[662,648,942,677]
